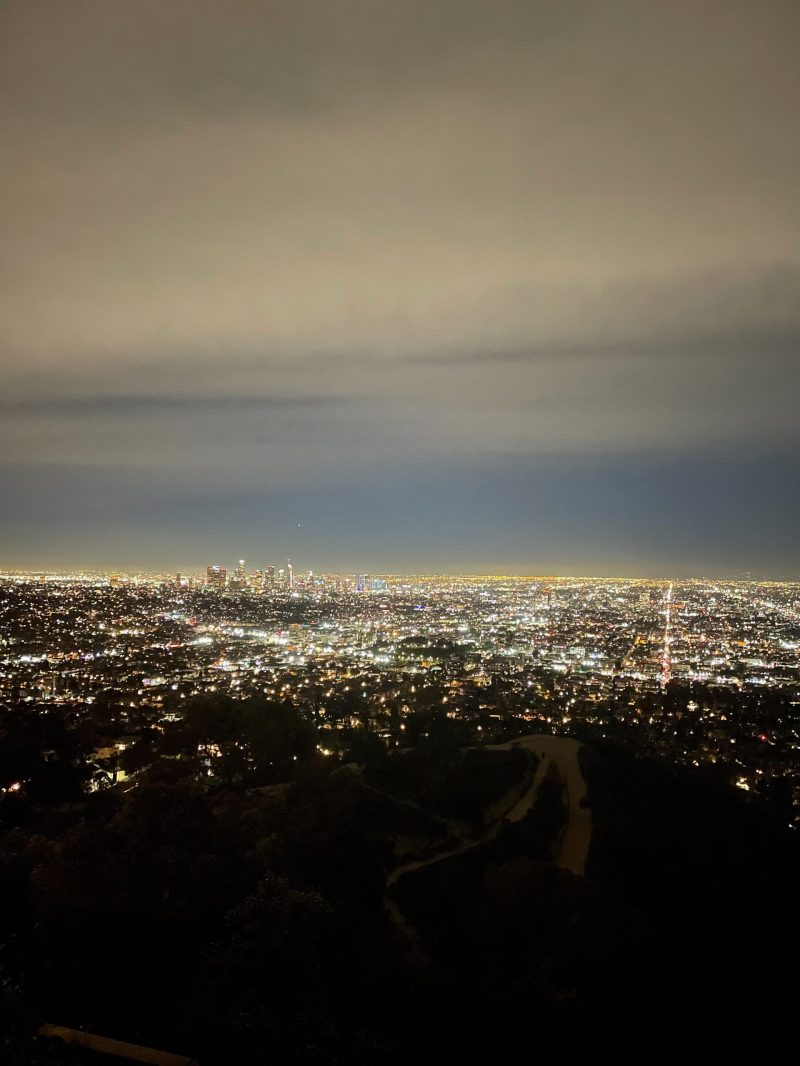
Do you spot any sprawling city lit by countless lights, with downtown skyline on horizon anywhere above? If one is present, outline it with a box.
[0,561,800,824]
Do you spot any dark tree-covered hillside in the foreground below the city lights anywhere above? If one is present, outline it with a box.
[0,701,799,1066]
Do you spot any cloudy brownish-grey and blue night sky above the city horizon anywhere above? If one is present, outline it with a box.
[0,0,800,577]
